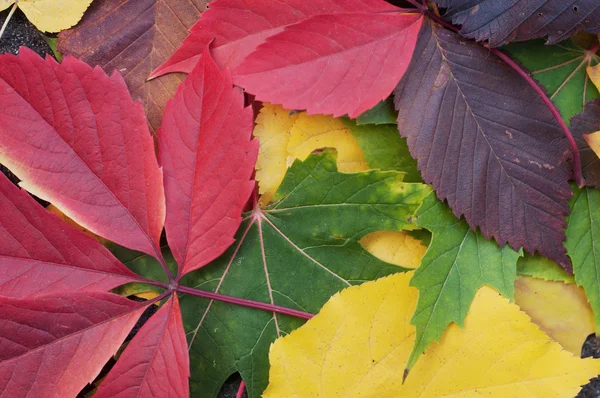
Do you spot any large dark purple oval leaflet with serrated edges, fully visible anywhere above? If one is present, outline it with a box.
[394,23,571,269]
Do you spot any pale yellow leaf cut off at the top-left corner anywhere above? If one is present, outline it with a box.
[0,0,92,32]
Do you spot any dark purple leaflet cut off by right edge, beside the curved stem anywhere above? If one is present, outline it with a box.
[571,99,600,188]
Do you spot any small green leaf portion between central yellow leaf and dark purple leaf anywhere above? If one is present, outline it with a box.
[344,119,423,182]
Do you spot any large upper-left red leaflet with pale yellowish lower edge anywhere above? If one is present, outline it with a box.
[0,48,164,256]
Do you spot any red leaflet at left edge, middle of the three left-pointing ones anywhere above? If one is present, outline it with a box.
[0,174,139,298]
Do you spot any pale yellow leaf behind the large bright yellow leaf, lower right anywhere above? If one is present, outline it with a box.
[515,276,595,355]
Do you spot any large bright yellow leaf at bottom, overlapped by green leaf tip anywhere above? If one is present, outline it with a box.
[264,273,600,398]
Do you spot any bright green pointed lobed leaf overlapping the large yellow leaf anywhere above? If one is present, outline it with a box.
[407,193,522,369]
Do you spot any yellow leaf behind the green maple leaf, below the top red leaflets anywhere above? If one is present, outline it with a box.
[254,103,369,206]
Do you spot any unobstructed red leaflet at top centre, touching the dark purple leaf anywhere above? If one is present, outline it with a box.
[234,13,422,117]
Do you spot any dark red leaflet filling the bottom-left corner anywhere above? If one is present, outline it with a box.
[0,293,148,397]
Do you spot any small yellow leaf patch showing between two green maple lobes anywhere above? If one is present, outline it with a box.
[359,231,427,268]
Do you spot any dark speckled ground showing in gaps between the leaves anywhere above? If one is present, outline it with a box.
[0,5,600,398]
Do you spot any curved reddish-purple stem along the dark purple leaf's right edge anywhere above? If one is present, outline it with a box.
[425,11,585,187]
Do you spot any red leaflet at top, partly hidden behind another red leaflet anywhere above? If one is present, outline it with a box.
[150,0,396,78]
